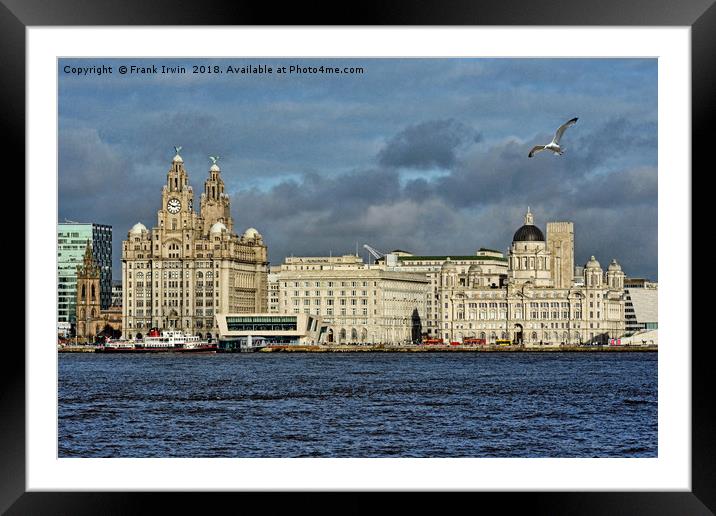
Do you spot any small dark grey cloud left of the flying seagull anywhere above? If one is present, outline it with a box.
[378,119,480,169]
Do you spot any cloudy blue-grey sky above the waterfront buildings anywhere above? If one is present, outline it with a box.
[58,58,658,279]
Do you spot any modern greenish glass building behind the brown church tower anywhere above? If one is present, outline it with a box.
[57,221,112,333]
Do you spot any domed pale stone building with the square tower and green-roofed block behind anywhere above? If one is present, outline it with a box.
[377,208,625,345]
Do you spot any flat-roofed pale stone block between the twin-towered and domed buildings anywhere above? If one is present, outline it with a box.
[278,255,429,343]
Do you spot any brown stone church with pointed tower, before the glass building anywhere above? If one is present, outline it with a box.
[75,241,122,341]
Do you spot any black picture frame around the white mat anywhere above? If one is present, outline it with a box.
[0,0,704,515]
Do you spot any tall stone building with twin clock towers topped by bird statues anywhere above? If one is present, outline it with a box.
[122,147,268,337]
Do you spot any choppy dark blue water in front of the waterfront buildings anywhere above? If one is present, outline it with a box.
[59,353,657,457]
